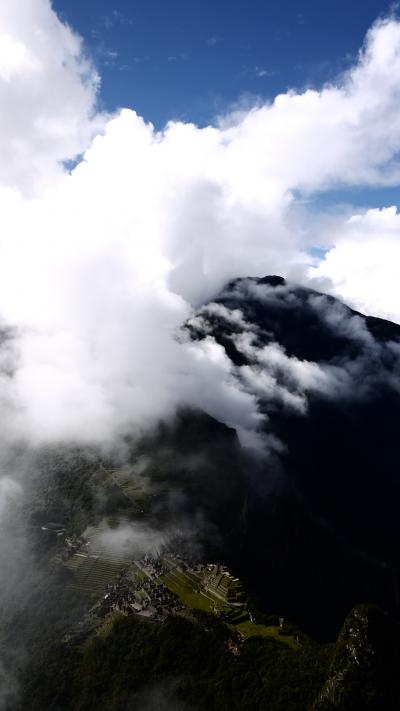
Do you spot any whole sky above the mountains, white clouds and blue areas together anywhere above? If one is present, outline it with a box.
[0,0,400,446]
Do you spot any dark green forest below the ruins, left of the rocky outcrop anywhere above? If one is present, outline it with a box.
[21,611,330,711]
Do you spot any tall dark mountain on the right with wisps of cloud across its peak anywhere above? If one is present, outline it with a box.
[187,277,400,637]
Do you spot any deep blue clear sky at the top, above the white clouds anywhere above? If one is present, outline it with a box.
[53,0,391,127]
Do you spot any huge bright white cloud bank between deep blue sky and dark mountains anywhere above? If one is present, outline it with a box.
[0,0,400,450]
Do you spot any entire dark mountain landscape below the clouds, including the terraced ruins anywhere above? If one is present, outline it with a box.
[0,276,400,711]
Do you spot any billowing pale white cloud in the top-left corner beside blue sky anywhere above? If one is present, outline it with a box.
[0,0,102,194]
